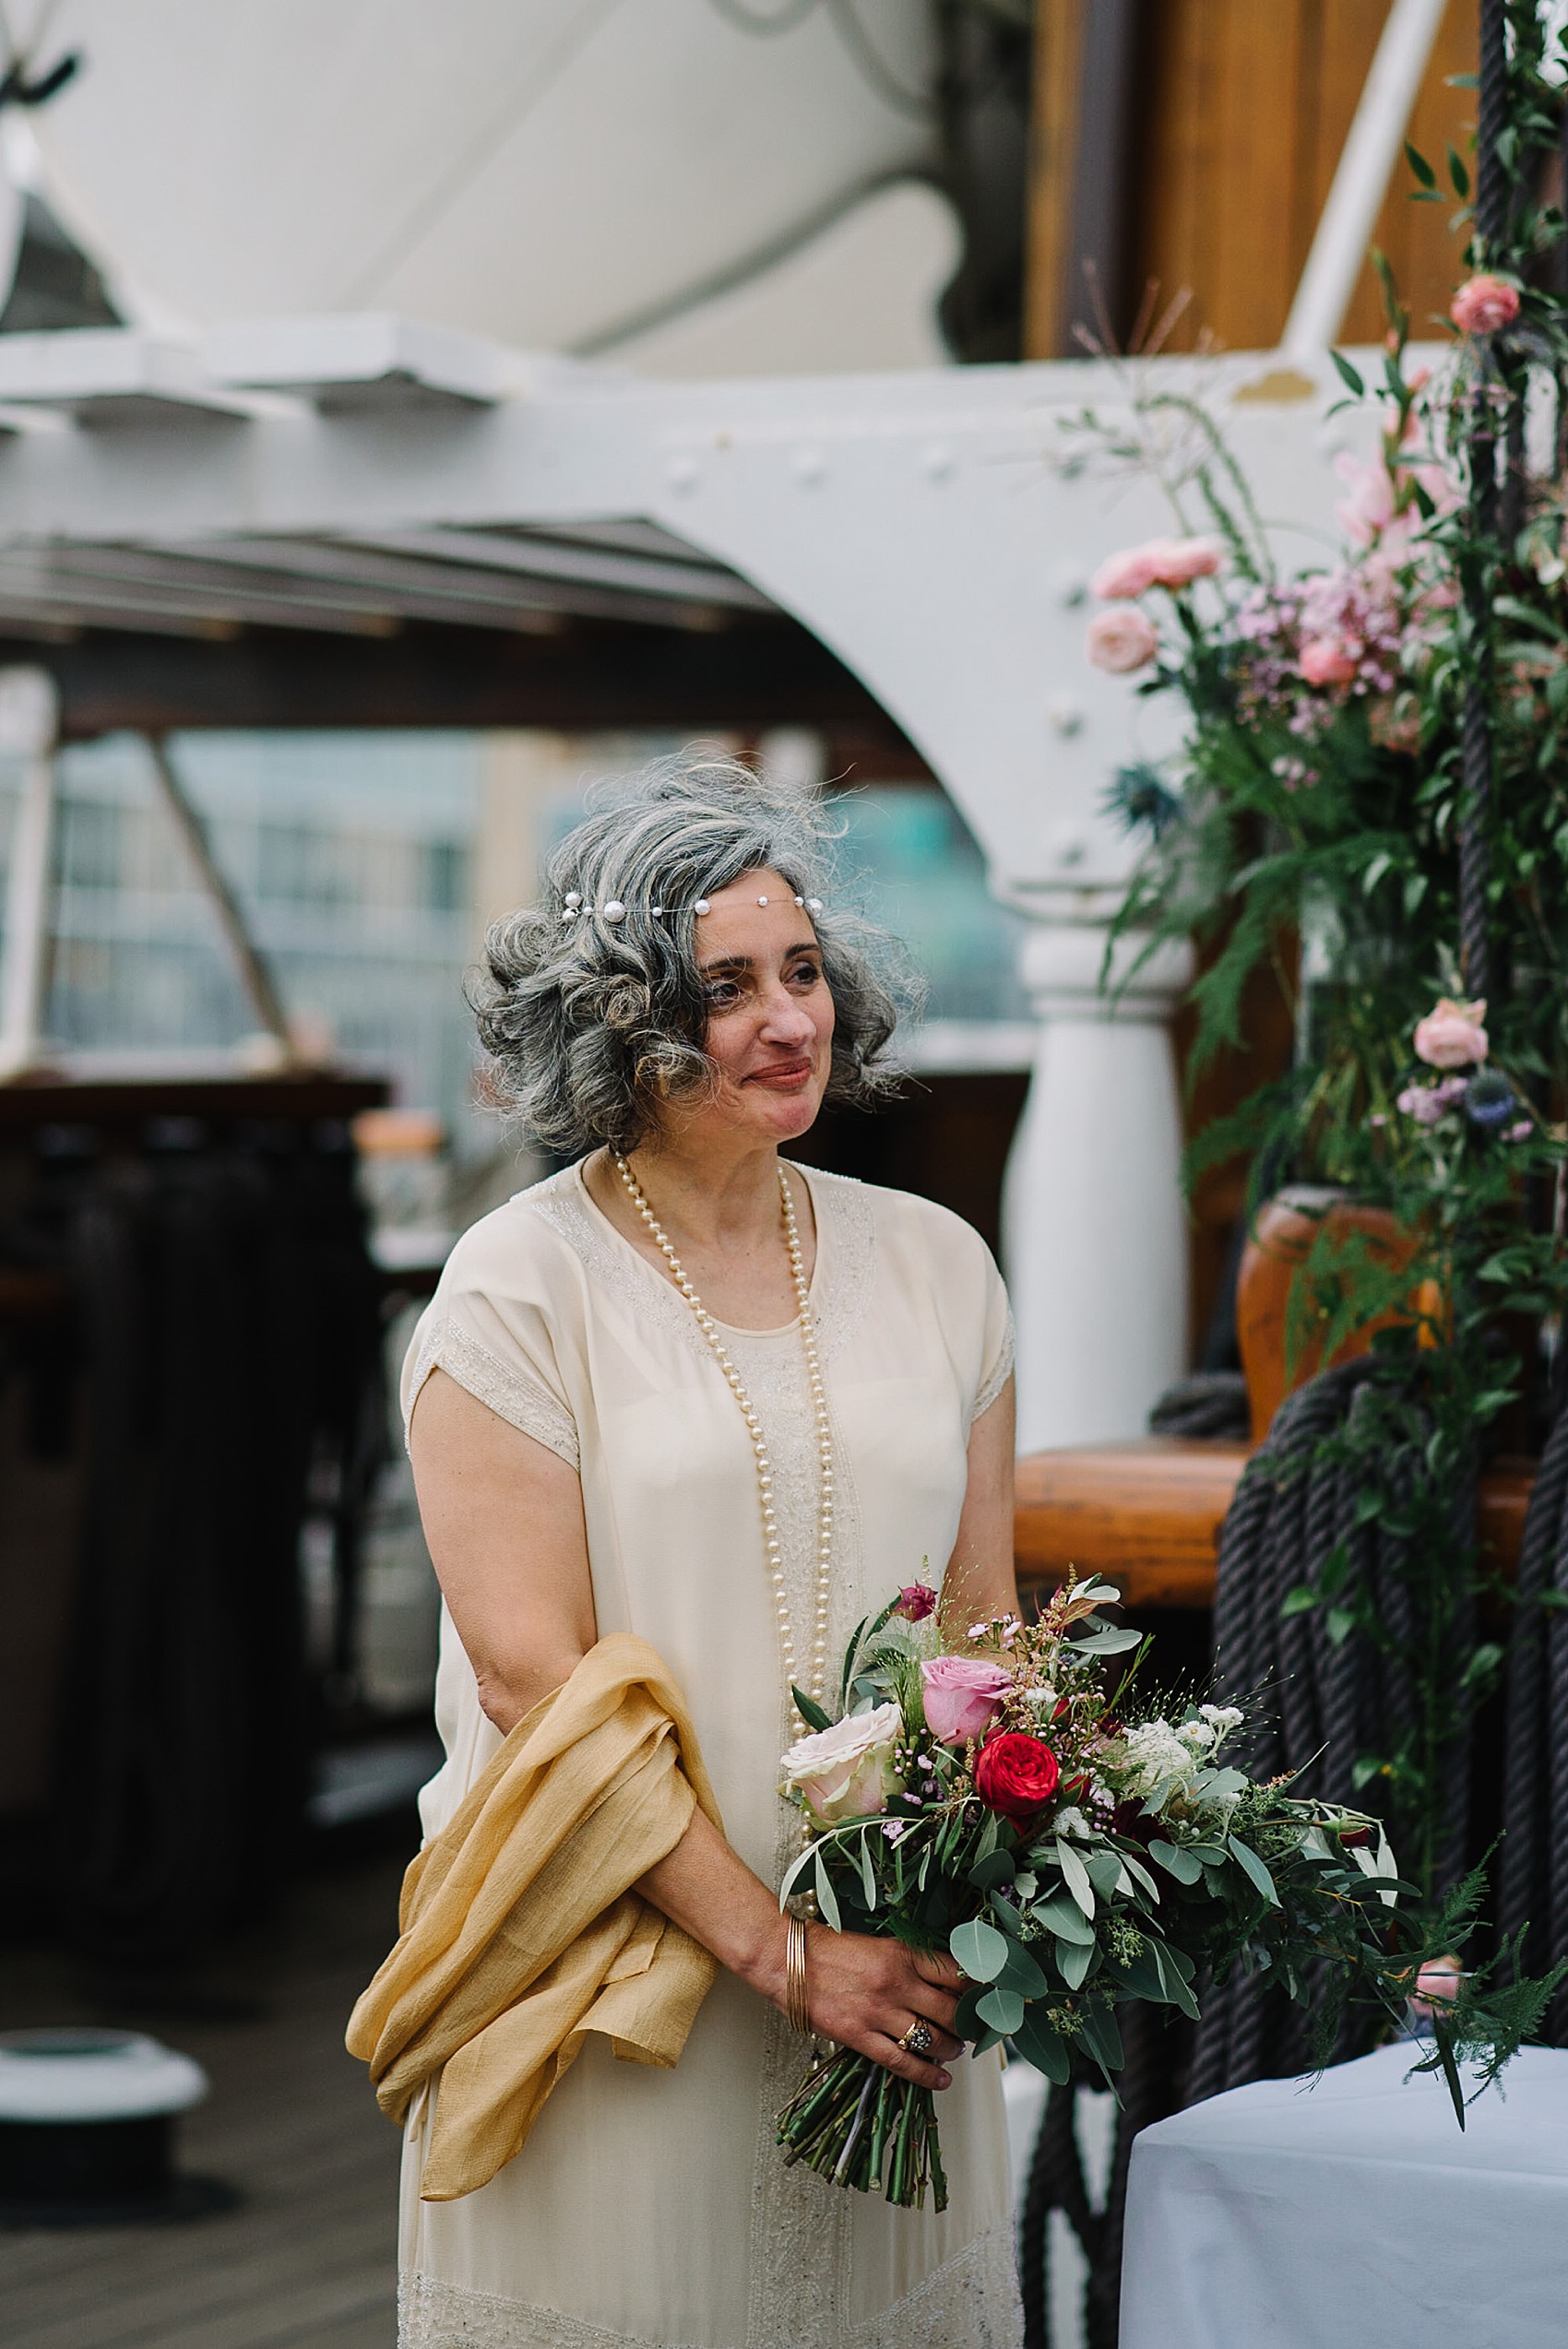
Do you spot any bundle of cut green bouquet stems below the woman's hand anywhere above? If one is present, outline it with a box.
[778,2048,947,2211]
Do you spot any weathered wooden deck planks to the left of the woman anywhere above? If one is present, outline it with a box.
[0,1863,402,2349]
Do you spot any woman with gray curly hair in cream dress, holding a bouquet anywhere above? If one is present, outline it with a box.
[399,761,1020,2349]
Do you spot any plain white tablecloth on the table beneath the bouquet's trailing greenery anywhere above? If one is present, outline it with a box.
[1122,2046,1568,2349]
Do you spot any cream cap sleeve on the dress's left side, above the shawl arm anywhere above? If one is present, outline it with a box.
[402,1193,578,1468]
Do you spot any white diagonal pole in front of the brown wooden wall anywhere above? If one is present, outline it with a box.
[1281,0,1448,360]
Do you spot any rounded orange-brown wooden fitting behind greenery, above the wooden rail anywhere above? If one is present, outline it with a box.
[1237,1186,1441,1442]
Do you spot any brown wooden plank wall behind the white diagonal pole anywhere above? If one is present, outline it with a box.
[1028,0,1477,357]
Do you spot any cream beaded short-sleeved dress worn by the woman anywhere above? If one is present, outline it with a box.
[399,1168,1023,2349]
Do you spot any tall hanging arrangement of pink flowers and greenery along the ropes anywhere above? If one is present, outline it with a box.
[1052,0,1568,1926]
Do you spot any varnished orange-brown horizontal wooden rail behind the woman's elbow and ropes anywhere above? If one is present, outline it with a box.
[1014,1435,1535,1607]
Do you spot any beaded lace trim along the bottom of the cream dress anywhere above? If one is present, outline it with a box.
[398,2226,1023,2349]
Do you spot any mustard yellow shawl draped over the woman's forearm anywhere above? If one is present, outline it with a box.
[348,1632,721,2201]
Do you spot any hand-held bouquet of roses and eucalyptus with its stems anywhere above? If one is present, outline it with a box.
[778,1579,1535,2211]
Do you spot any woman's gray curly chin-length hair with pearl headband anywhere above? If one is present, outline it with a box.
[470,754,920,1158]
